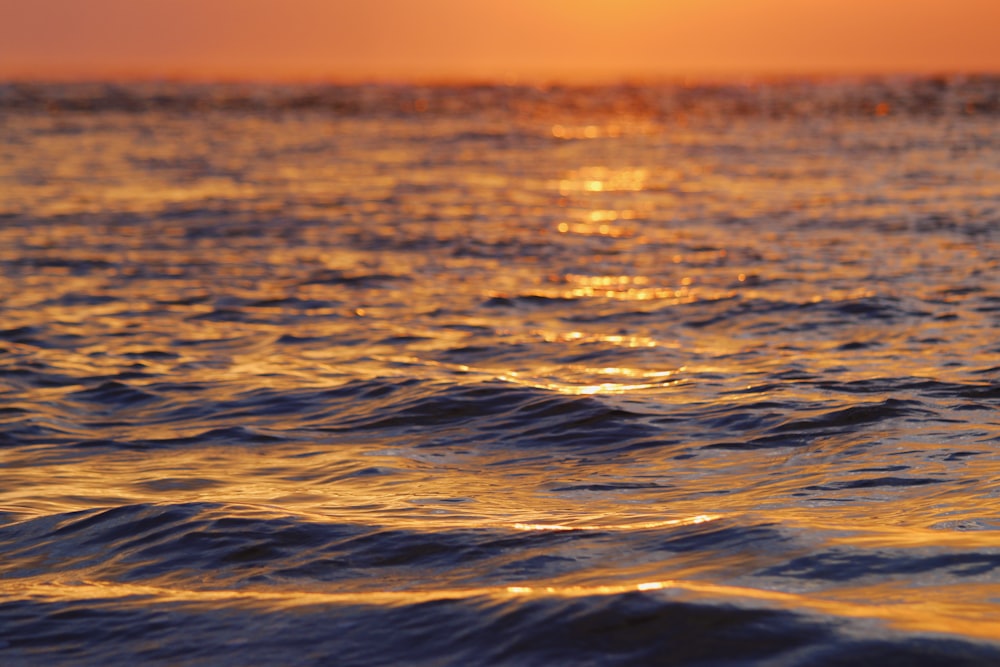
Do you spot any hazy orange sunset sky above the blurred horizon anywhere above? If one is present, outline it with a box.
[0,0,1000,81]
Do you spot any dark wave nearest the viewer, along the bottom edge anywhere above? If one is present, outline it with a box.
[0,586,1000,667]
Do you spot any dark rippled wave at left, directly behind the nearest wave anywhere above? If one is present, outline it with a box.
[0,500,632,590]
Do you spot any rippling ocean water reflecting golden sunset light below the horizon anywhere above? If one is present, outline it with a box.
[0,77,1000,667]
